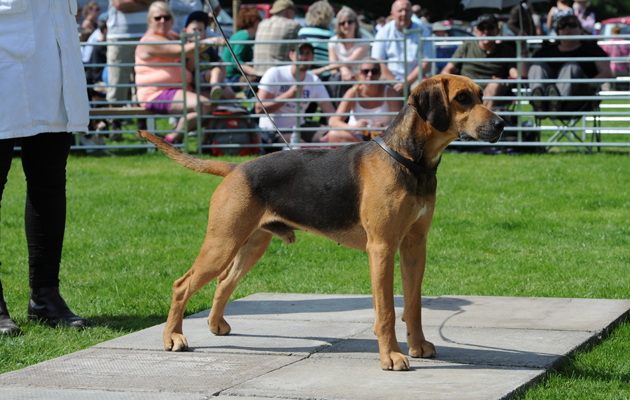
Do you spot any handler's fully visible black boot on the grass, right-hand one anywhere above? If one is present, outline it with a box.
[27,288,90,328]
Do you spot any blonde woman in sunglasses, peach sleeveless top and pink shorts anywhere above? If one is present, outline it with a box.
[135,1,218,143]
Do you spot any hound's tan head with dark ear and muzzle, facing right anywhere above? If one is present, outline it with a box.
[408,75,505,143]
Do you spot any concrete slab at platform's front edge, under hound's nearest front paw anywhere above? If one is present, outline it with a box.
[222,358,545,400]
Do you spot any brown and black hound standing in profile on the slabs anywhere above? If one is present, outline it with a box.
[141,75,505,370]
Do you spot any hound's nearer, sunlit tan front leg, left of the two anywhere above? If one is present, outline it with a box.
[367,239,409,371]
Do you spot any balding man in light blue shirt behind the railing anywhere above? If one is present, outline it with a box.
[372,0,433,94]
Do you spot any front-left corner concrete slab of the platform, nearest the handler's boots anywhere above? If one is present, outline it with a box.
[0,348,301,398]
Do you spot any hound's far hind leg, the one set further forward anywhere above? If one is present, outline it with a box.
[208,230,273,335]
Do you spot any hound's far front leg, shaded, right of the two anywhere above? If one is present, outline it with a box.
[400,219,436,358]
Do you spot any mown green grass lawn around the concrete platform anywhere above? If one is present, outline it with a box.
[0,141,630,399]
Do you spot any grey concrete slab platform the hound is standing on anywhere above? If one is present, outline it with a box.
[0,293,630,400]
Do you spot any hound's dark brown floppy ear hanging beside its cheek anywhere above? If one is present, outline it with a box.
[409,78,451,132]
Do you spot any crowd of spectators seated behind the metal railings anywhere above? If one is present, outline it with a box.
[73,0,628,149]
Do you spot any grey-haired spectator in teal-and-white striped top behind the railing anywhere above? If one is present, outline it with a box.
[298,0,335,81]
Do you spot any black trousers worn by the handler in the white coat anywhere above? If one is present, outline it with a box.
[0,132,72,288]
